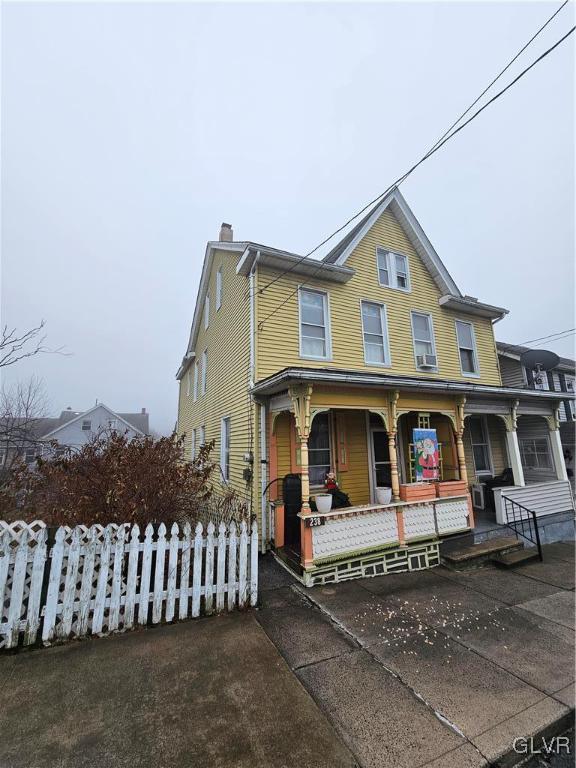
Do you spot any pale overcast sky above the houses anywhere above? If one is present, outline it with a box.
[2,2,575,431]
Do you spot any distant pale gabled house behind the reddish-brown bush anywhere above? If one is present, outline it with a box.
[40,403,149,456]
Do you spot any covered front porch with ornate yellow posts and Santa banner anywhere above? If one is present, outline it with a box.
[255,368,565,584]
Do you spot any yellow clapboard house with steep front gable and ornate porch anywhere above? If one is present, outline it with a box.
[177,190,573,584]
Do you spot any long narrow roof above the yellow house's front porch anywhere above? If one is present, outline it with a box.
[251,368,574,402]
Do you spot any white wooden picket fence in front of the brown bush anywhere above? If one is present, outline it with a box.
[0,521,258,649]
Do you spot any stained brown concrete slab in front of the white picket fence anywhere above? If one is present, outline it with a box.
[0,613,355,768]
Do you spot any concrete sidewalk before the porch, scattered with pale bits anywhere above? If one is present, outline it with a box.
[258,544,574,768]
